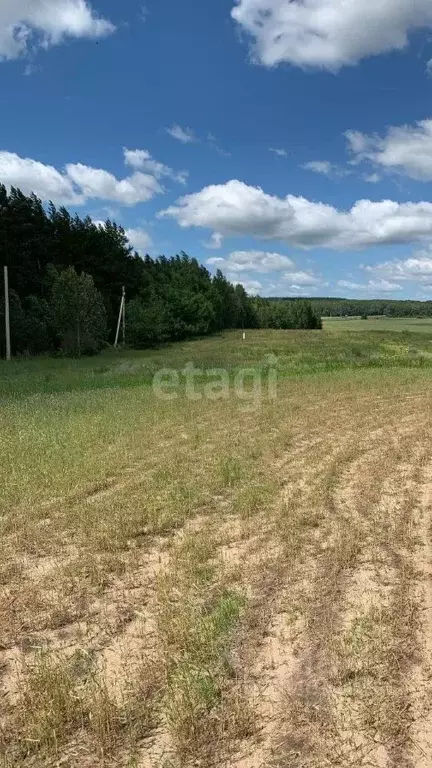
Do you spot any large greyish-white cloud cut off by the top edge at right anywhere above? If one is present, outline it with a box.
[231,0,432,71]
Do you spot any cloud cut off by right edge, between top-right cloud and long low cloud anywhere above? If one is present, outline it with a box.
[345,120,432,181]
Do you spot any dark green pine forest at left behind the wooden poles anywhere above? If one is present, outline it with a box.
[0,184,321,355]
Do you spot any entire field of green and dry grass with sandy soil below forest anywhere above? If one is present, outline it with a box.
[0,328,432,768]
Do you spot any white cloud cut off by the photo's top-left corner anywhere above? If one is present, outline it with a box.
[0,0,115,61]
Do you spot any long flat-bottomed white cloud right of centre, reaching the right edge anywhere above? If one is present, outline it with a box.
[159,180,432,250]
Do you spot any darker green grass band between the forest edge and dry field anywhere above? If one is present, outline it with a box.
[0,326,432,403]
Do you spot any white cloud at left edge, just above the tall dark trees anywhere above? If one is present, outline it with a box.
[0,152,163,205]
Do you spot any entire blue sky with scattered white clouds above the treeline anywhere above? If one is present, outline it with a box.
[0,0,432,298]
